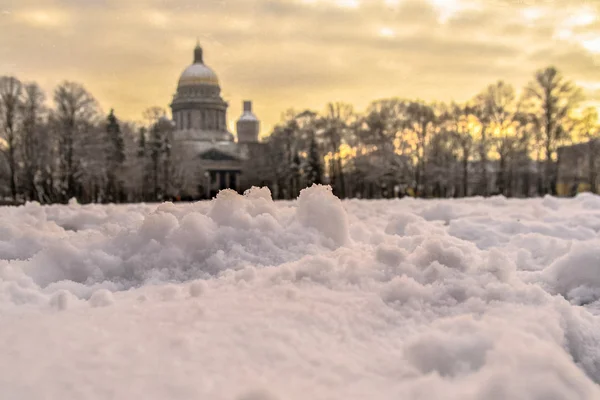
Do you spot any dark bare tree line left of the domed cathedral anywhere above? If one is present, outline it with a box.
[0,76,183,204]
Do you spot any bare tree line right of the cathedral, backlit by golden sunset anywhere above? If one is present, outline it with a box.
[252,67,600,202]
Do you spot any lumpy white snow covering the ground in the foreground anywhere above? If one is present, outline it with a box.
[0,187,600,400]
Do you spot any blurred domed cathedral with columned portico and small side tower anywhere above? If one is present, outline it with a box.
[171,44,260,198]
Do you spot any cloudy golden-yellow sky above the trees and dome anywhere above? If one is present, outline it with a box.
[0,0,600,135]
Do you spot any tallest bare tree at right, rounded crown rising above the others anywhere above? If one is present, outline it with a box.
[526,67,582,193]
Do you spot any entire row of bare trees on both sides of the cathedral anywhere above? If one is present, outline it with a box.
[0,67,600,203]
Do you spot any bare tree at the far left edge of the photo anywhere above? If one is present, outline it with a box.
[0,76,22,201]
